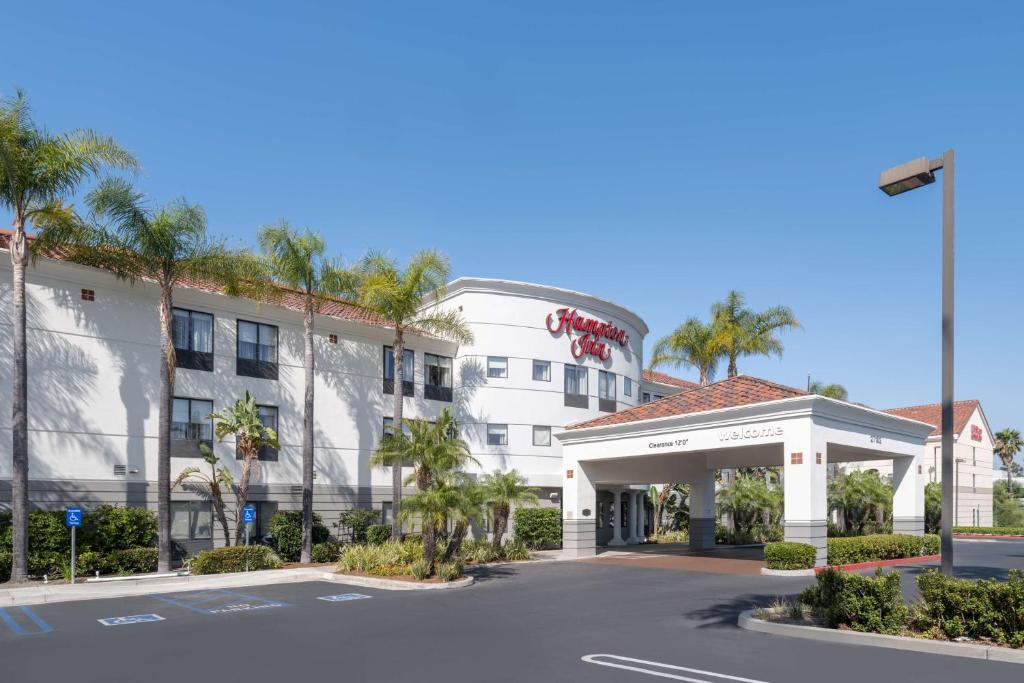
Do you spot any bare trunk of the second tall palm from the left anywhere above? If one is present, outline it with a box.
[157,285,174,571]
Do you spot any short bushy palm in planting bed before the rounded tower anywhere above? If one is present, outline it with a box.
[370,408,479,571]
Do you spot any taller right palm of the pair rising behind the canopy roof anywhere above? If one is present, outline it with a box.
[711,290,800,377]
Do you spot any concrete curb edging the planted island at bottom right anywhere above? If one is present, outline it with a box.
[736,609,1024,664]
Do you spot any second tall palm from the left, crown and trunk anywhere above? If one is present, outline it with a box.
[35,178,262,571]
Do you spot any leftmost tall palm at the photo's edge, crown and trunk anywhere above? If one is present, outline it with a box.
[0,90,138,582]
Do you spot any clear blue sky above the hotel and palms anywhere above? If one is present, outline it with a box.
[6,0,1024,436]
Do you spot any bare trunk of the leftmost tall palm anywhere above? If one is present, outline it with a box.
[10,222,29,583]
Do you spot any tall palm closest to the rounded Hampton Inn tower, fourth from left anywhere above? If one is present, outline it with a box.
[351,250,473,539]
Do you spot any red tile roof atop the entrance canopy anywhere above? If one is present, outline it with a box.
[566,375,807,429]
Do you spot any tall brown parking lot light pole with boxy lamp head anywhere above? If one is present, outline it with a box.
[879,150,955,577]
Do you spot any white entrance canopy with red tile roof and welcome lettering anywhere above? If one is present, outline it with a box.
[557,376,933,563]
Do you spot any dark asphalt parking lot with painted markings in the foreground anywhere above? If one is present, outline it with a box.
[0,542,1024,683]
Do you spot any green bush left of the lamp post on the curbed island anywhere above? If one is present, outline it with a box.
[798,569,908,634]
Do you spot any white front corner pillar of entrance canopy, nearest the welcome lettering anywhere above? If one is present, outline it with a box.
[782,430,828,566]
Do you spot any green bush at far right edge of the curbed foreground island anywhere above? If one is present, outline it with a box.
[915,569,1024,647]
